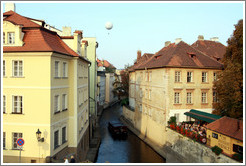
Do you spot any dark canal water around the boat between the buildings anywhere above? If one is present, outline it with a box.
[97,104,165,163]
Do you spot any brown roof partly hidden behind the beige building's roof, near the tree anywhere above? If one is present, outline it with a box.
[191,40,226,61]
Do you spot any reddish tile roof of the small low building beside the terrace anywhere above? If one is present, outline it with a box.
[207,116,243,141]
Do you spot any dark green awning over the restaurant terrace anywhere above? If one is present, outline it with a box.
[184,109,221,123]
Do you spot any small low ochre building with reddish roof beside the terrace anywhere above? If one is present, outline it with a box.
[207,116,243,156]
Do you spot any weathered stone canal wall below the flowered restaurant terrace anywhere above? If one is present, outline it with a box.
[121,106,238,163]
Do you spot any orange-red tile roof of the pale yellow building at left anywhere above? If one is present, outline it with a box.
[3,11,90,63]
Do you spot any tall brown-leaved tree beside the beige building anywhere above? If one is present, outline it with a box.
[213,20,243,118]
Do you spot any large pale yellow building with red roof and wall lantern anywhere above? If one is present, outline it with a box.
[2,7,90,163]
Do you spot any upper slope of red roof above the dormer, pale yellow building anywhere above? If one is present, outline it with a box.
[3,10,41,28]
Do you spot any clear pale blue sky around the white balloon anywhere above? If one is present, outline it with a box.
[1,1,244,69]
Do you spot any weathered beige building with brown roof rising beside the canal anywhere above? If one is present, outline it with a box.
[124,39,223,145]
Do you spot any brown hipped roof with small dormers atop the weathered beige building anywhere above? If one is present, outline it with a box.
[137,41,223,69]
